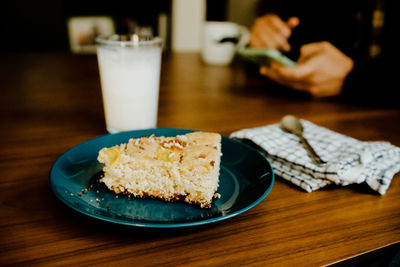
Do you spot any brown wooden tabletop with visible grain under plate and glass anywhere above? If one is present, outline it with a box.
[0,53,400,266]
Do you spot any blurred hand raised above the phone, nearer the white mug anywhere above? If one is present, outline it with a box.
[250,14,300,52]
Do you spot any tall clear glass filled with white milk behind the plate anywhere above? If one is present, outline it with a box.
[96,34,163,133]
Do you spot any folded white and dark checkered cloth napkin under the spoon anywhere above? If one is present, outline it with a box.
[231,120,400,195]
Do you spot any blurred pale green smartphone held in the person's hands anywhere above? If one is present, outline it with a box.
[238,47,296,67]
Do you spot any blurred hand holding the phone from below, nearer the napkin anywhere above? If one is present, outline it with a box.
[260,42,354,97]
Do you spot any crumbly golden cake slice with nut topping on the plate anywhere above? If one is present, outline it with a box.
[97,132,221,208]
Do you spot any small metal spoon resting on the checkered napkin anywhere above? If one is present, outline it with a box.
[281,115,326,164]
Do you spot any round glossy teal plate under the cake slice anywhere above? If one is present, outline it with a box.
[50,128,274,228]
